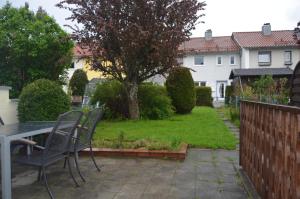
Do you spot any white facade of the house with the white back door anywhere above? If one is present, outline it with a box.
[183,52,241,98]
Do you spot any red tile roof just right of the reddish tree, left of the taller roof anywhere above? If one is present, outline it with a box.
[179,36,239,53]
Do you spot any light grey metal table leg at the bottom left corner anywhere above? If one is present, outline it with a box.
[1,138,11,199]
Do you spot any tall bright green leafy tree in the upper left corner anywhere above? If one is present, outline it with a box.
[0,3,74,97]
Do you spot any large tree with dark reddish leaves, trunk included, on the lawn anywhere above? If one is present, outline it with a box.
[57,0,206,119]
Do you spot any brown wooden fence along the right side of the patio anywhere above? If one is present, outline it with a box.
[240,101,300,199]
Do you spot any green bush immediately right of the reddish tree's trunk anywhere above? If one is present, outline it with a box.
[138,83,173,119]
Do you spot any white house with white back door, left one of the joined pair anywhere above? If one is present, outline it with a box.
[179,30,241,101]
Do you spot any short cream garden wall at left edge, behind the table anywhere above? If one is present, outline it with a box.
[0,86,18,124]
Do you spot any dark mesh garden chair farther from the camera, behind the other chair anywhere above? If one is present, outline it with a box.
[64,105,104,182]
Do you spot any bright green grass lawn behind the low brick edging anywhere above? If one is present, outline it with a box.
[94,107,237,149]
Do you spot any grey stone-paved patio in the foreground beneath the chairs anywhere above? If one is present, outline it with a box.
[9,149,248,199]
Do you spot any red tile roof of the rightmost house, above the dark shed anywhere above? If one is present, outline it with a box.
[232,30,299,48]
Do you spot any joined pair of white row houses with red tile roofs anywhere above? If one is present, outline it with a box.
[180,24,300,101]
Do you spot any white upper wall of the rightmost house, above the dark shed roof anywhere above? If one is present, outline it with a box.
[247,48,300,69]
